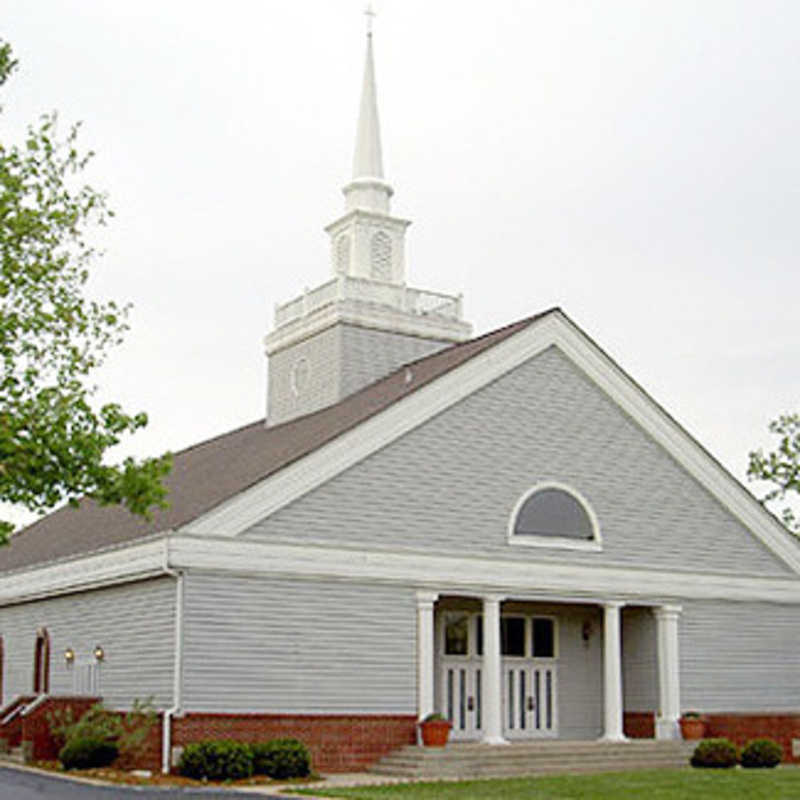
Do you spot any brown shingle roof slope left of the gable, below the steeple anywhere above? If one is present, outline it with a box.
[0,309,556,572]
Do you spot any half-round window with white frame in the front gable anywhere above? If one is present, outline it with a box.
[509,483,601,550]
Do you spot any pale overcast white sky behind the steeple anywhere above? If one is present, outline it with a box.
[0,0,800,528]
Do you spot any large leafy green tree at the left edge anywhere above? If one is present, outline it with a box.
[0,41,171,542]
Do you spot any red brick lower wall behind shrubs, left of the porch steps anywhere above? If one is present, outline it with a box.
[172,713,416,772]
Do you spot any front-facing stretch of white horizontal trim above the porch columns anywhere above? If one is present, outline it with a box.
[168,535,800,605]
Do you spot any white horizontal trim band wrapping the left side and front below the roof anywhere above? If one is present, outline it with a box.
[0,535,800,606]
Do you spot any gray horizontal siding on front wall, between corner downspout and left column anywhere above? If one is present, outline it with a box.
[184,572,416,714]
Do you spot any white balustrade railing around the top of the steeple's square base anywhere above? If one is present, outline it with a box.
[275,275,461,327]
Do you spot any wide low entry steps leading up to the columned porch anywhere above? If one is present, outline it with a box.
[369,739,694,780]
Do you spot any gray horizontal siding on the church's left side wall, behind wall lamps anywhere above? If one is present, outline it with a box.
[0,577,175,708]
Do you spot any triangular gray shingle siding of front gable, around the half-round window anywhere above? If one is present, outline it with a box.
[244,348,790,575]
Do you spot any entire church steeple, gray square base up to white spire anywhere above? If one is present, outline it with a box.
[265,9,472,425]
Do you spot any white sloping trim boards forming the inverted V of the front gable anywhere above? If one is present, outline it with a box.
[181,310,800,573]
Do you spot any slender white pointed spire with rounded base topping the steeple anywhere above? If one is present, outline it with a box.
[342,5,393,214]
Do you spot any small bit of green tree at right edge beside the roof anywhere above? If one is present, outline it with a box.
[747,414,800,536]
